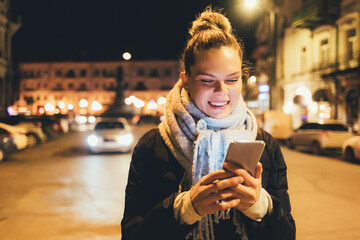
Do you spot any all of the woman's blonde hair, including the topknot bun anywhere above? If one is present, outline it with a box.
[181,7,243,75]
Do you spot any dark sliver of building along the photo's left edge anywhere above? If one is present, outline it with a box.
[0,0,21,116]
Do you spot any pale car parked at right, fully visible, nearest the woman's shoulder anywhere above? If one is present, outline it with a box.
[286,123,353,154]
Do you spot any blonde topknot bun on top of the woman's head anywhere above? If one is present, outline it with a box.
[189,9,232,37]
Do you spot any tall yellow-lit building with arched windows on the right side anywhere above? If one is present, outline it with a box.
[255,0,360,127]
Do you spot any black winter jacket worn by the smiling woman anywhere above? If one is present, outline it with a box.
[121,128,295,240]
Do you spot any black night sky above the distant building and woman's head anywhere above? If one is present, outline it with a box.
[10,0,258,64]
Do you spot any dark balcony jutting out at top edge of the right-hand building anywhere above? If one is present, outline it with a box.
[292,0,340,30]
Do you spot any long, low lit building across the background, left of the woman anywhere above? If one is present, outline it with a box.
[11,60,179,115]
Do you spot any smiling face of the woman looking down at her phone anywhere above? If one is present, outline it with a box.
[181,47,242,118]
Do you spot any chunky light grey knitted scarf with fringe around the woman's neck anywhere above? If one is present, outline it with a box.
[159,80,257,240]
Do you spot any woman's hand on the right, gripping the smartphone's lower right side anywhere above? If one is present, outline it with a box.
[224,162,263,211]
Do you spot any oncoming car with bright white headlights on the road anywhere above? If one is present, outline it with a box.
[86,118,134,153]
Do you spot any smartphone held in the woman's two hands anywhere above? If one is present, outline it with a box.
[225,140,265,176]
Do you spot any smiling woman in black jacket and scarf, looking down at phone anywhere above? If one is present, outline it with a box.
[122,9,295,240]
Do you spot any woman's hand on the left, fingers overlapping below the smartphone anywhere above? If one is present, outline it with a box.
[190,169,244,216]
